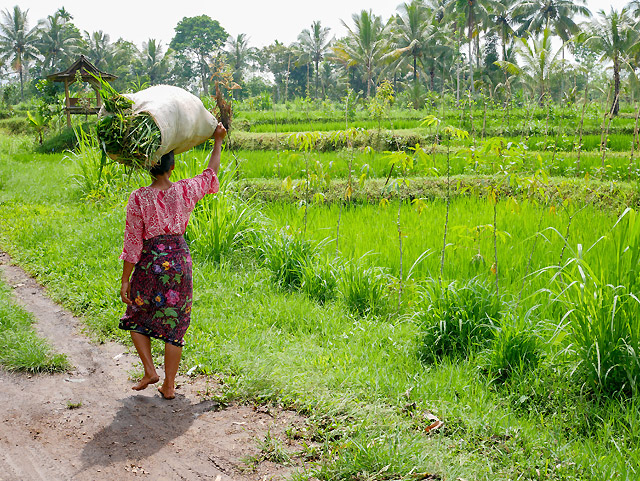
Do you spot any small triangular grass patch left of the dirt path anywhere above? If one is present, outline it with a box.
[0,283,69,373]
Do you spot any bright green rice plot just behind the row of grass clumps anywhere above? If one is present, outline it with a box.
[262,197,616,293]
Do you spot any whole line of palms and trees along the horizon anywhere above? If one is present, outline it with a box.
[0,0,640,114]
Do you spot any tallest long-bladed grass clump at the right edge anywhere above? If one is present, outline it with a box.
[552,209,640,394]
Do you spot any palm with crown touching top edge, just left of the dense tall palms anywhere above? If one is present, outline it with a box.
[393,0,435,89]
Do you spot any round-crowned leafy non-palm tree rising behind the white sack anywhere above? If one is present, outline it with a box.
[170,15,229,94]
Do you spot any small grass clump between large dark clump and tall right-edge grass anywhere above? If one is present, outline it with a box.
[479,309,544,384]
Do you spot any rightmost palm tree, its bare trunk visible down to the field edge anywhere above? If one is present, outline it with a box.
[584,7,640,115]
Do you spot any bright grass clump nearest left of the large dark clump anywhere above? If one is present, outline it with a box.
[338,258,392,316]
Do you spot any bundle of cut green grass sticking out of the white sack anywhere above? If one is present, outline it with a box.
[97,82,162,169]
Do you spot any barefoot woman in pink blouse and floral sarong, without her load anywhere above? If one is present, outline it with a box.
[119,123,227,399]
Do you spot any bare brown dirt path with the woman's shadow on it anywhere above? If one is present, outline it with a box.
[0,253,304,481]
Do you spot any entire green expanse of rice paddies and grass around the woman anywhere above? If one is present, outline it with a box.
[0,100,640,480]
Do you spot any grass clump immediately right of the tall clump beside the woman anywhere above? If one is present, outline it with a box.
[259,231,320,290]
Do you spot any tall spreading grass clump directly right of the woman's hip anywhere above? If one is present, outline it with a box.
[186,192,265,263]
